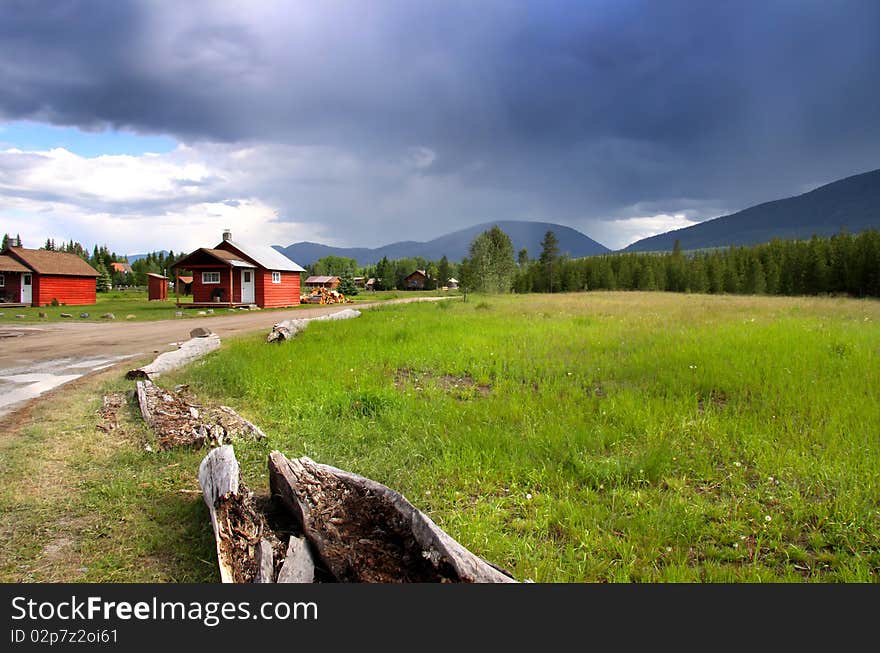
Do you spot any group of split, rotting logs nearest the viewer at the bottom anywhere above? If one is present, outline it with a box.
[199,445,516,583]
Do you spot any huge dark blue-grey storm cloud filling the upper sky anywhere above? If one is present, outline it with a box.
[0,0,880,244]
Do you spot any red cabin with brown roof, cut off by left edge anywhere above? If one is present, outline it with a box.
[0,247,98,306]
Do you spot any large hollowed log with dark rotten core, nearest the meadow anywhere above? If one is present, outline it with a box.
[269,451,516,583]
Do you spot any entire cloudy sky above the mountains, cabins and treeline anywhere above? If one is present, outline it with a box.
[0,0,880,254]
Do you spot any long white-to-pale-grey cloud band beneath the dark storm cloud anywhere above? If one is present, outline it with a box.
[0,143,544,254]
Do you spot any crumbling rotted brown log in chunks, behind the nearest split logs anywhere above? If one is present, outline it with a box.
[137,381,266,449]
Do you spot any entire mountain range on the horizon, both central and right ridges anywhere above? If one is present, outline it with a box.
[270,170,880,265]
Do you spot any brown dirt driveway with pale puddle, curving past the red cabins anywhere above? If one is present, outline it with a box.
[0,297,446,416]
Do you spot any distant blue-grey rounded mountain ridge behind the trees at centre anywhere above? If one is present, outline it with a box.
[274,220,611,265]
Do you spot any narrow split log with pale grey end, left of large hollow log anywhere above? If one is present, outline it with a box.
[199,444,239,583]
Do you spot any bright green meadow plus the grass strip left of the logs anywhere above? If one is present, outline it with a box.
[0,293,880,582]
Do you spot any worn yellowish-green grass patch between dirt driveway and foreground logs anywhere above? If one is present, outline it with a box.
[0,368,223,582]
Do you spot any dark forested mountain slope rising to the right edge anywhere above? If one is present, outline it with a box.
[623,170,880,252]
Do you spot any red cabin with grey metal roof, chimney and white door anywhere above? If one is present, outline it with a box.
[172,230,305,308]
